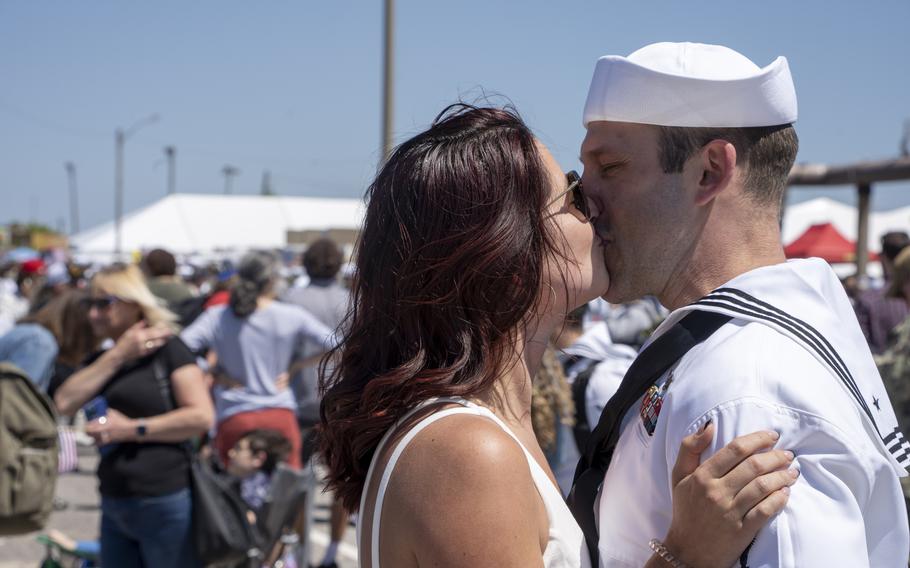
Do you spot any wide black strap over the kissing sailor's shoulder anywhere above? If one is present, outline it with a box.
[568,311,732,566]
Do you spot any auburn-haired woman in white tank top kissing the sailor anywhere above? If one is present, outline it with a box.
[321,105,792,568]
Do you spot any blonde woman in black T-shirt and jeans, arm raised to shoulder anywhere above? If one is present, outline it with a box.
[54,264,214,568]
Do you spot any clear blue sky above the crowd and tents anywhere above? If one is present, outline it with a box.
[0,0,910,233]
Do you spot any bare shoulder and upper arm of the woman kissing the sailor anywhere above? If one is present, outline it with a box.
[382,414,548,566]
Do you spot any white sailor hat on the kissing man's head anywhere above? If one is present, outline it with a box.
[584,42,797,128]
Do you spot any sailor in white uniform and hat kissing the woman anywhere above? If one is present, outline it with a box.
[570,43,910,567]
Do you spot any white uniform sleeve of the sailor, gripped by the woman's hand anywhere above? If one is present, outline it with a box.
[667,398,884,568]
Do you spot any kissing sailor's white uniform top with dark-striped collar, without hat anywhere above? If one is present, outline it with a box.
[596,259,910,568]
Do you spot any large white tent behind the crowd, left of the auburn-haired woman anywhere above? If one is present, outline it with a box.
[70,194,364,258]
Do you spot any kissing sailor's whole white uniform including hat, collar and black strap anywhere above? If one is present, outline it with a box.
[569,43,910,568]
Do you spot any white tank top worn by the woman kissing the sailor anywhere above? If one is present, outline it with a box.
[357,397,591,568]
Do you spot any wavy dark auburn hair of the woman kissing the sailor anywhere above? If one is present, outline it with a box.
[320,104,561,511]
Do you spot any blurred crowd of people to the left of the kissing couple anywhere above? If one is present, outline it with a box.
[0,239,348,566]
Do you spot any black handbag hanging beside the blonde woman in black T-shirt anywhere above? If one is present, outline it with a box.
[153,357,261,565]
